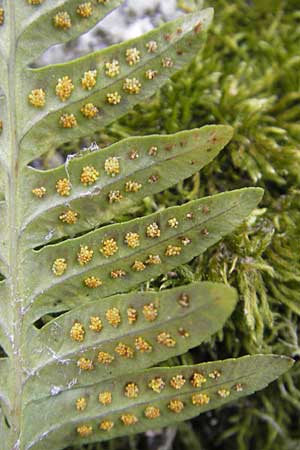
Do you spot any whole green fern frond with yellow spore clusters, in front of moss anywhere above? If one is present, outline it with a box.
[0,0,291,450]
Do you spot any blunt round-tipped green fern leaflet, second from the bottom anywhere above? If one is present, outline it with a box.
[24,282,237,402]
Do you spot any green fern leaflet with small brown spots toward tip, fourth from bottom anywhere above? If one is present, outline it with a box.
[20,125,232,247]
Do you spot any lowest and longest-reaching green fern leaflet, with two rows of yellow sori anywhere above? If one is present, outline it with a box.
[24,355,292,450]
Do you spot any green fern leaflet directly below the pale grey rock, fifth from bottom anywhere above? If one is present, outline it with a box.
[19,9,212,162]
